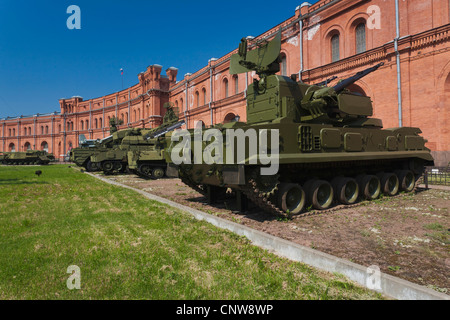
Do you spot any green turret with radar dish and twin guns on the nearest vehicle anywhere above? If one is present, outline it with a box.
[230,29,383,127]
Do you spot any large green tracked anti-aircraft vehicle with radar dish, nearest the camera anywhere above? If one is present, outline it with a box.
[169,30,433,216]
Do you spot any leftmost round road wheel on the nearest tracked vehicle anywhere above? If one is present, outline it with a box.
[278,183,306,214]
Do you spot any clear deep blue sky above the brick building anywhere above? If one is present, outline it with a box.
[0,0,317,118]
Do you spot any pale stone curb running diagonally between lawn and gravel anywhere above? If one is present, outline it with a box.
[85,172,450,300]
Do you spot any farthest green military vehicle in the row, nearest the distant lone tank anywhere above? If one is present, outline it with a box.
[69,118,126,172]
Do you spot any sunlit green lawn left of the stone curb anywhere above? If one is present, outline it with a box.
[0,165,381,299]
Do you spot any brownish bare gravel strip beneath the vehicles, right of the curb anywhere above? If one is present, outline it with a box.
[96,175,450,294]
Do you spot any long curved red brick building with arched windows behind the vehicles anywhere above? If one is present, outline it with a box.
[0,0,450,165]
